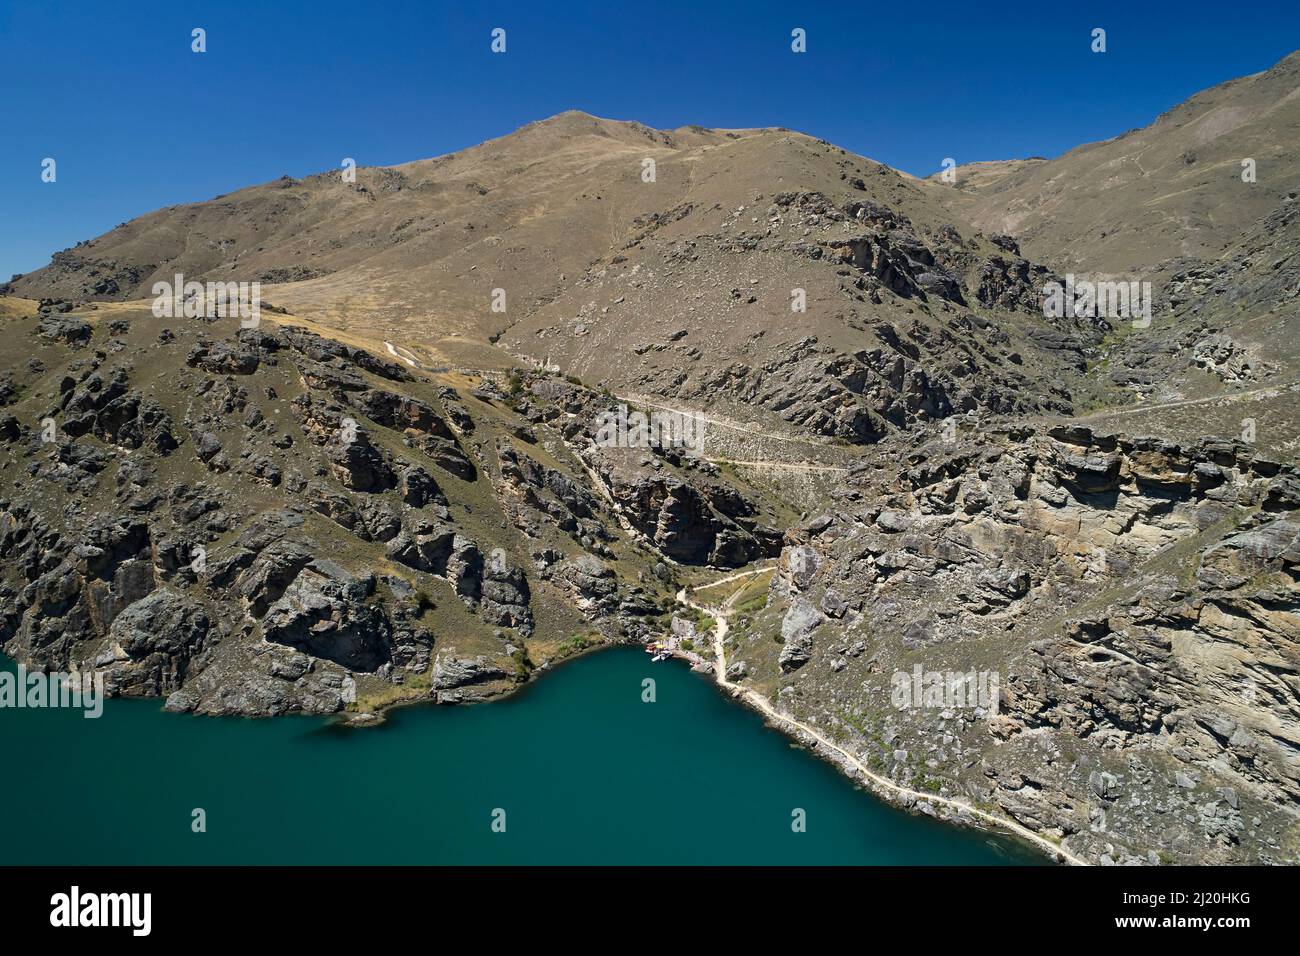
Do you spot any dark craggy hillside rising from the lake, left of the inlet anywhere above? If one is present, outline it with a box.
[0,299,789,714]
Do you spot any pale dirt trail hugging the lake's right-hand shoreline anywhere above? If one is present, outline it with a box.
[677,568,1089,866]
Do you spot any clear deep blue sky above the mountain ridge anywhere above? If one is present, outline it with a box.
[0,0,1300,278]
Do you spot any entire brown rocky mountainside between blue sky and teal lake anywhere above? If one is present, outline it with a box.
[0,56,1300,862]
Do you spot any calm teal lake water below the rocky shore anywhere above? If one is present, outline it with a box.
[0,648,1044,865]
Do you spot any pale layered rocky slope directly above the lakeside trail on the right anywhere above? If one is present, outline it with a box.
[733,427,1300,862]
